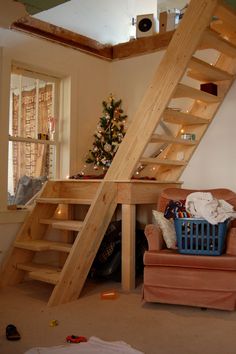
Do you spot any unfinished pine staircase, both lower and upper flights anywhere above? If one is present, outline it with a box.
[1,0,236,305]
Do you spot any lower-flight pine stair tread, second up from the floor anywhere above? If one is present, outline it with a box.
[14,240,72,253]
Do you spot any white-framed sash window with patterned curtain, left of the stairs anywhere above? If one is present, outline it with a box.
[8,65,59,205]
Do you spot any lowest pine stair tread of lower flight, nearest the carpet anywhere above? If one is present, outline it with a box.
[17,263,61,285]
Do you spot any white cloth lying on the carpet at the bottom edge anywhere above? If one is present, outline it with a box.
[25,337,144,354]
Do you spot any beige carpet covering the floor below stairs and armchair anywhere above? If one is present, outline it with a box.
[0,282,236,354]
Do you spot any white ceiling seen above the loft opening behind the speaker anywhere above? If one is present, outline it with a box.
[34,0,188,45]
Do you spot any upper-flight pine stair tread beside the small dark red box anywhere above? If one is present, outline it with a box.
[173,84,220,103]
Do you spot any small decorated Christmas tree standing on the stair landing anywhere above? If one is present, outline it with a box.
[86,95,127,171]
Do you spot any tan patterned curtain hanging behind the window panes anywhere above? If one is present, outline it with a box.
[12,84,53,194]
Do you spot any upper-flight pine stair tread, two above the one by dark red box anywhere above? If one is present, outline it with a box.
[201,29,236,58]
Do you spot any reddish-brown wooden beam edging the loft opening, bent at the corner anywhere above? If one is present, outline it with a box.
[11,16,174,60]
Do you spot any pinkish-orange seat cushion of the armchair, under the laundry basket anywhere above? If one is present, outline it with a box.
[144,249,236,271]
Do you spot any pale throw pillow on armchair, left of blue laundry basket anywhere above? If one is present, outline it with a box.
[152,210,176,249]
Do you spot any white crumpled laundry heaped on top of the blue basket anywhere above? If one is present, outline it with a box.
[185,192,236,225]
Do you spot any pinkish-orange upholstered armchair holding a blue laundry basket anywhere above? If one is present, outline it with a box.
[143,188,236,311]
